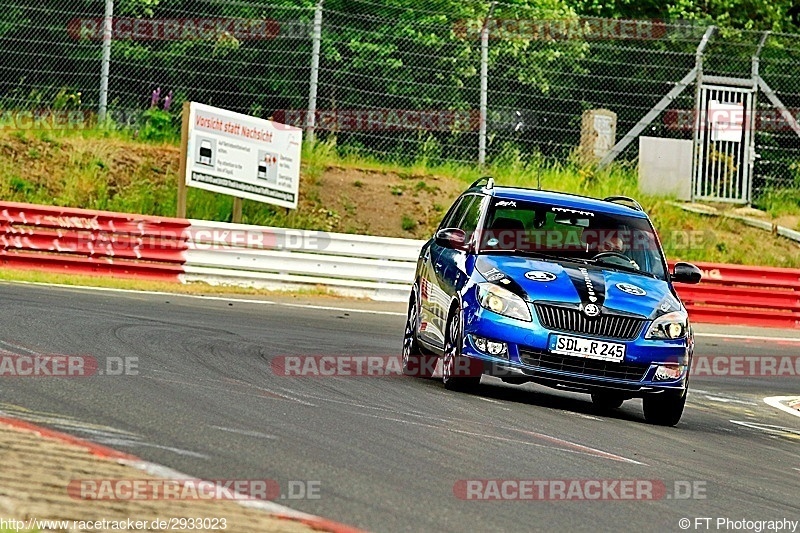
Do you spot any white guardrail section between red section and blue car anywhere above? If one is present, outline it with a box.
[184,220,424,302]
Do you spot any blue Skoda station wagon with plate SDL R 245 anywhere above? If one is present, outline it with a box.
[403,178,701,426]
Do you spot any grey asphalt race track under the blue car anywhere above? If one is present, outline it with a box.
[0,284,800,532]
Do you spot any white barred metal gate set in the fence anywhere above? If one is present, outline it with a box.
[694,84,755,204]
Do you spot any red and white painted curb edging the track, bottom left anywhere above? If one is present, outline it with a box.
[0,417,365,533]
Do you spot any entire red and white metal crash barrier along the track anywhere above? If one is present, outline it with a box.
[0,202,800,329]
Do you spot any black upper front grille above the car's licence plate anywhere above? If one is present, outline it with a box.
[535,303,645,340]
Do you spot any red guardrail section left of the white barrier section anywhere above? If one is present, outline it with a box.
[0,202,190,281]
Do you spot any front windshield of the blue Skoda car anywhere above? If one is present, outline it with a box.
[479,198,666,279]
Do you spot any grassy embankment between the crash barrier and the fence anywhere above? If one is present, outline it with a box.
[0,124,800,267]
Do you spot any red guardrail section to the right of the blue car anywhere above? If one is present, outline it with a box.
[670,263,800,329]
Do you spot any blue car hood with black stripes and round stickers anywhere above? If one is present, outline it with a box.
[475,255,681,318]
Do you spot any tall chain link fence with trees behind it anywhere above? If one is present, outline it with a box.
[0,0,800,195]
